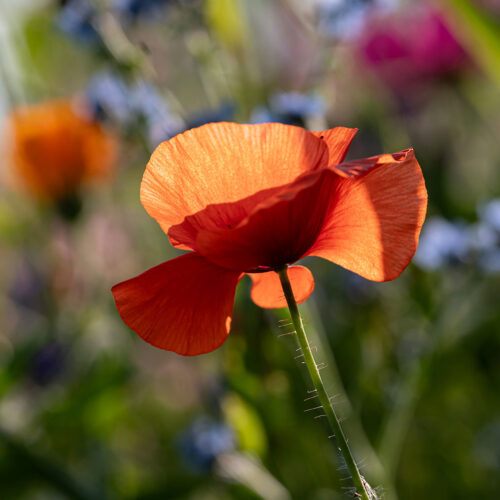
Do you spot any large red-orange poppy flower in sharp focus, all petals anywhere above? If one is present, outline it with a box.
[112,123,427,356]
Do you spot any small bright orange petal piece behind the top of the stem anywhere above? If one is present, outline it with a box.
[249,266,314,309]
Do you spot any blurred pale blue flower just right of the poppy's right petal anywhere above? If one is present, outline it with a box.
[414,217,471,271]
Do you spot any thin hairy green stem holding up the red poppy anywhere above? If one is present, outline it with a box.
[277,266,376,500]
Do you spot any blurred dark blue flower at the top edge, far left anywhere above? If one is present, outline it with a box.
[56,0,99,44]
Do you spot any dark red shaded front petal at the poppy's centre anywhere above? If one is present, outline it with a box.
[196,169,340,273]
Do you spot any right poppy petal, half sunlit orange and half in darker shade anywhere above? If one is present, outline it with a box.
[307,149,427,281]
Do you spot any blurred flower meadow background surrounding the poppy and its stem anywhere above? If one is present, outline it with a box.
[0,0,500,500]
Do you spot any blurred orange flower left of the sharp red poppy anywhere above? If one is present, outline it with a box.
[8,100,117,202]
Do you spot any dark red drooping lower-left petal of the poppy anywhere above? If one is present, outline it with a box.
[111,253,241,356]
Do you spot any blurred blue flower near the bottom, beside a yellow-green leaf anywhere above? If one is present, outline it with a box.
[178,417,235,472]
